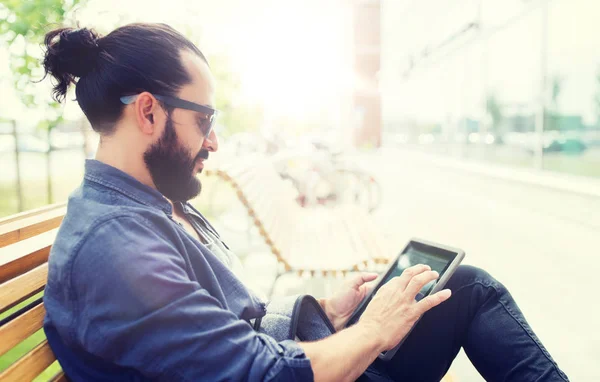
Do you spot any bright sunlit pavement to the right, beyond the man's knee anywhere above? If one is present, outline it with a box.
[364,150,600,382]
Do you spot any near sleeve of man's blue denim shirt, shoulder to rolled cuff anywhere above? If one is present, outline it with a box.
[71,216,313,381]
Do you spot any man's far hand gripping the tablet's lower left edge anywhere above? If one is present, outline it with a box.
[319,272,378,331]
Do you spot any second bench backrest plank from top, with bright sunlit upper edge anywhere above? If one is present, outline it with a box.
[0,229,58,283]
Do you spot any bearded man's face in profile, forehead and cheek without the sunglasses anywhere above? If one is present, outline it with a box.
[144,52,218,201]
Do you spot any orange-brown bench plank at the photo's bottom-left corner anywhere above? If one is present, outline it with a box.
[0,340,56,382]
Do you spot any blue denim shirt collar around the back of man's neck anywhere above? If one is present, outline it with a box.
[84,159,173,216]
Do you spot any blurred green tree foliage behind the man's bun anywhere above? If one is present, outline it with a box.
[0,0,81,129]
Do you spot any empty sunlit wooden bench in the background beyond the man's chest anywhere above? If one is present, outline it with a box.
[206,157,393,284]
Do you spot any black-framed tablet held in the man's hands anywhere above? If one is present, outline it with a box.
[347,241,458,326]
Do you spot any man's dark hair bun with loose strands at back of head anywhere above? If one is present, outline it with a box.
[43,28,100,102]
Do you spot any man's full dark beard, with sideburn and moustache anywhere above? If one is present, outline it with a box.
[144,115,208,202]
